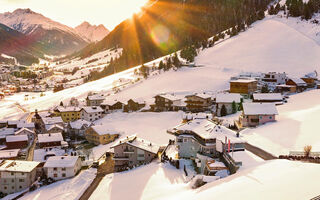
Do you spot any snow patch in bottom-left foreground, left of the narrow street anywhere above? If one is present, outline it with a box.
[20,168,97,200]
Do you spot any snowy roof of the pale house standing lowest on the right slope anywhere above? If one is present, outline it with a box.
[243,103,278,115]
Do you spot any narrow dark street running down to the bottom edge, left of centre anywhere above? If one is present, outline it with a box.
[79,156,114,200]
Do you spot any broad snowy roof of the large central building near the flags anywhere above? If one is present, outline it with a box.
[173,119,242,142]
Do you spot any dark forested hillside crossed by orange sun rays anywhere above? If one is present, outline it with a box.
[75,0,271,80]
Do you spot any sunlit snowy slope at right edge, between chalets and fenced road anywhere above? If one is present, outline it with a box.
[241,90,320,155]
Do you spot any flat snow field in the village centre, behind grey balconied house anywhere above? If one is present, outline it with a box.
[93,112,182,159]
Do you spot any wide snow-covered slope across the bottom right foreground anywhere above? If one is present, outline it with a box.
[90,155,320,200]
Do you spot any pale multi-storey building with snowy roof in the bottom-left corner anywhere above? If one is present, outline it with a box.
[0,160,39,194]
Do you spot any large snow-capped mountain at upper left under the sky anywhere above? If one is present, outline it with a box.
[0,9,87,55]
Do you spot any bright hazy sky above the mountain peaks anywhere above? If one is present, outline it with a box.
[0,0,147,30]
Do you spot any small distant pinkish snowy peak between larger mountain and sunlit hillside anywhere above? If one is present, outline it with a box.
[75,22,109,42]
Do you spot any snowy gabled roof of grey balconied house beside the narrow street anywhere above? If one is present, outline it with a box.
[111,135,160,154]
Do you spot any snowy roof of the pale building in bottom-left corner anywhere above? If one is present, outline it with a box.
[0,160,40,173]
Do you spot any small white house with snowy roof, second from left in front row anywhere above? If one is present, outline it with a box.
[43,156,81,180]
